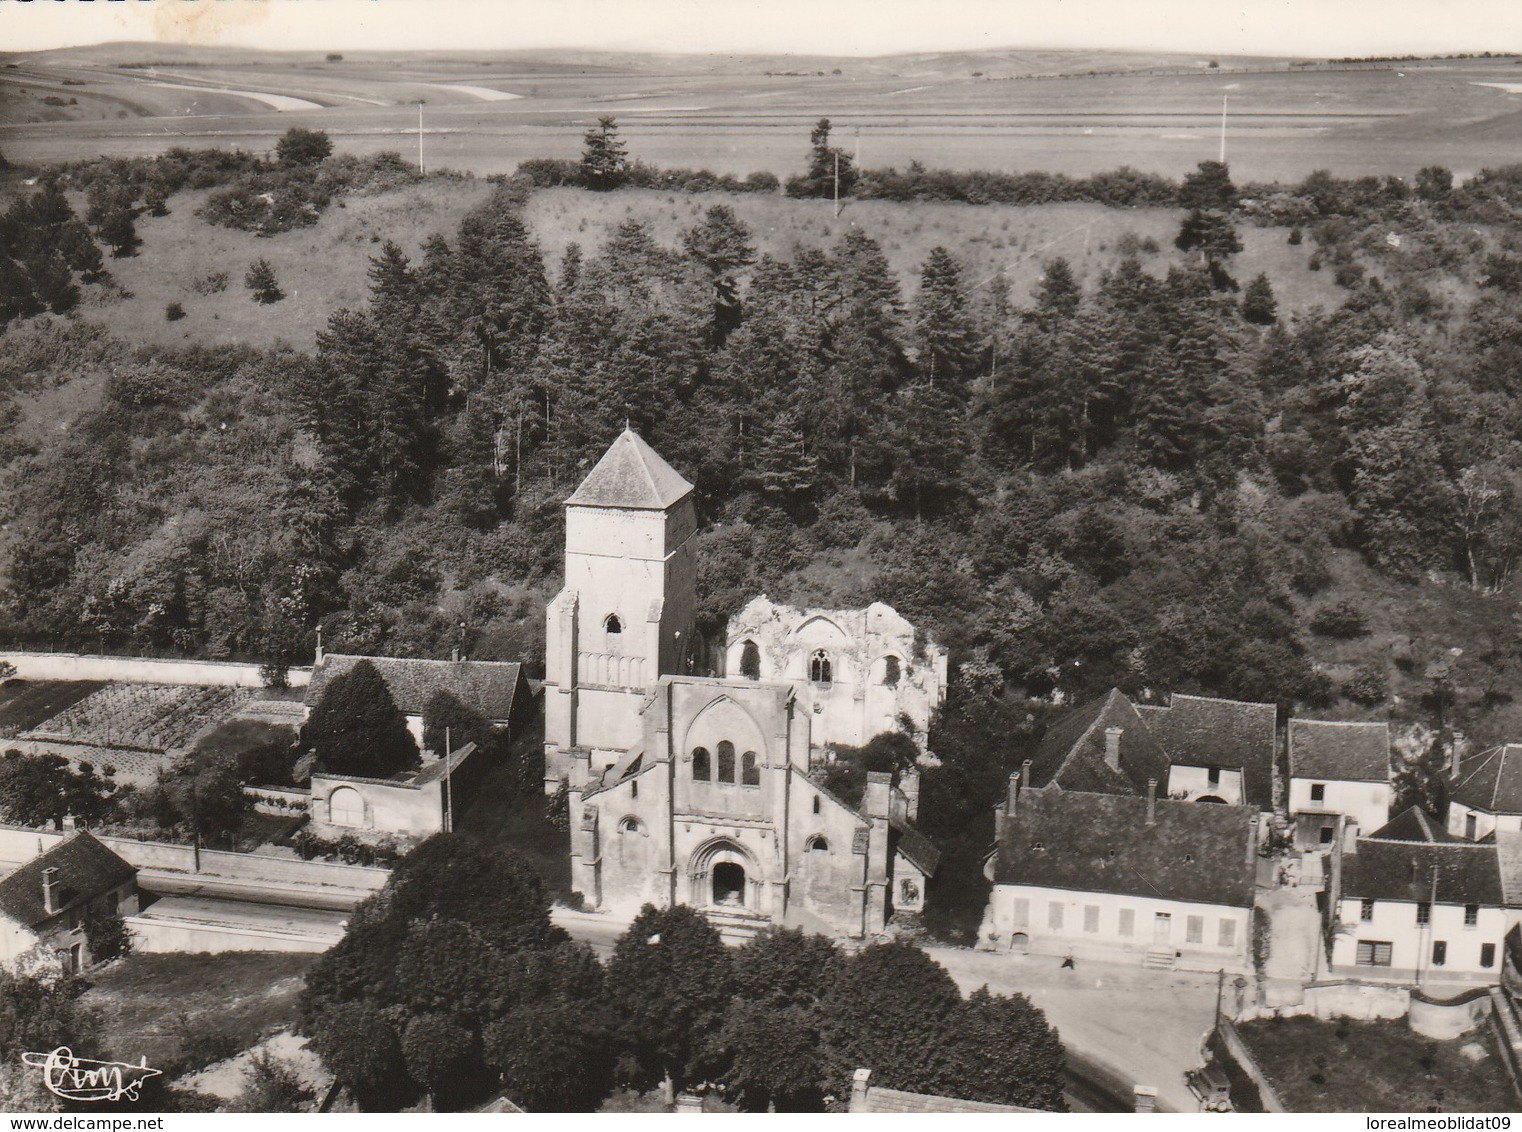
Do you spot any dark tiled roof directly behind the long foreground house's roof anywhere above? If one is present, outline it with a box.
[1137,694,1278,809]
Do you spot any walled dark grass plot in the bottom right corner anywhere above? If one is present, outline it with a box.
[1239,1018,1516,1112]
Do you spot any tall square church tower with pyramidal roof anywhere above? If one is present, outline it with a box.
[545,429,697,791]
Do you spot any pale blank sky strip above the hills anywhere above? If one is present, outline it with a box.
[0,0,1522,56]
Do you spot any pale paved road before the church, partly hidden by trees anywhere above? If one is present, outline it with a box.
[552,908,1216,1112]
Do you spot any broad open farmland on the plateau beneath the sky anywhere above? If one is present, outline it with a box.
[0,44,1522,181]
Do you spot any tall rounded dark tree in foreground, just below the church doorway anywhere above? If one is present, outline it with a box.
[607,904,731,1088]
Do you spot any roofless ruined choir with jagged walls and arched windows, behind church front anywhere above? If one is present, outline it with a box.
[724,596,947,750]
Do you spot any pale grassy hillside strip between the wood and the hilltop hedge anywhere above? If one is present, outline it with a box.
[71,174,1363,350]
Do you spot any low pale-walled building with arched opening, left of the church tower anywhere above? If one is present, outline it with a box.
[307,742,474,838]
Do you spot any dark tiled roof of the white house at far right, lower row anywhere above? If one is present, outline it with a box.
[1342,837,1505,907]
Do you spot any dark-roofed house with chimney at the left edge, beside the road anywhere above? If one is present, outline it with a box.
[0,829,139,974]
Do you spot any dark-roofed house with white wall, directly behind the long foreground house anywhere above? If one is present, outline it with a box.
[1137,692,1278,811]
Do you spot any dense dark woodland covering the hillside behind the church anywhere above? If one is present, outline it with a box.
[0,123,1522,937]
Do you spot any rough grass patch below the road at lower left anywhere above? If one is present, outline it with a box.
[82,951,317,1065]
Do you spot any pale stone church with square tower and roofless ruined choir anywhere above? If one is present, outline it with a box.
[545,429,947,939]
